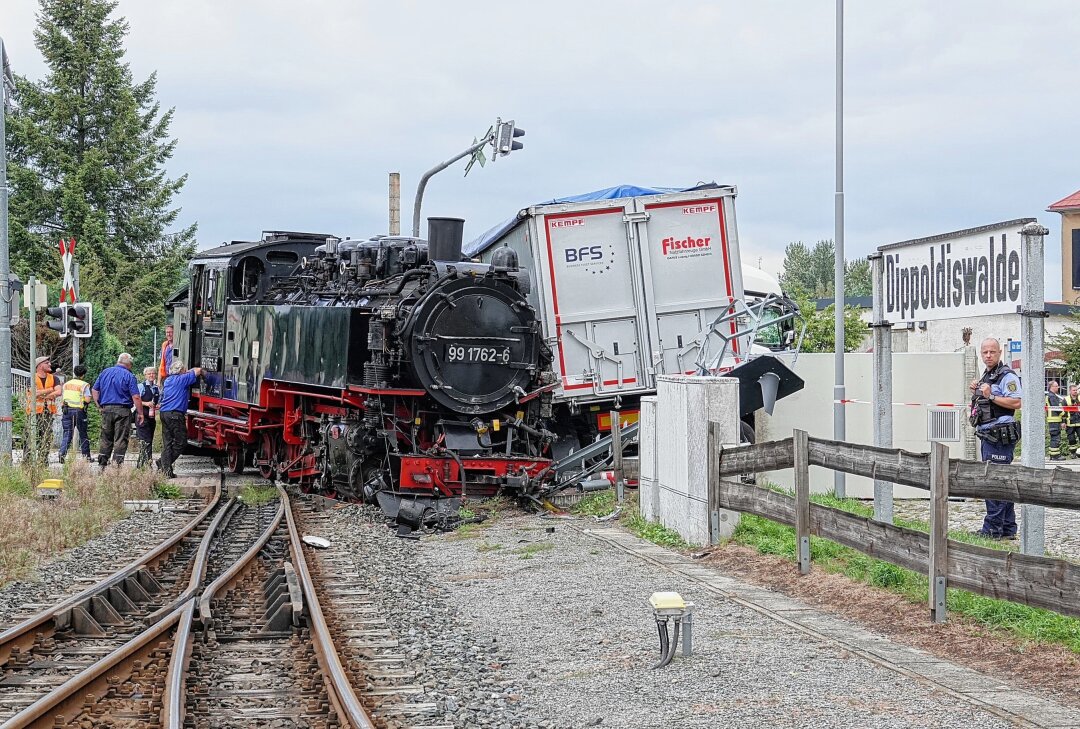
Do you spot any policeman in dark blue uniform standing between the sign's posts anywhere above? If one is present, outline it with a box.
[971,339,1022,539]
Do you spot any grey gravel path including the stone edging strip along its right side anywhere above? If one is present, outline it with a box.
[420,517,1080,729]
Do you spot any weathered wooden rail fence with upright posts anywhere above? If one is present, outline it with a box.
[708,423,1080,622]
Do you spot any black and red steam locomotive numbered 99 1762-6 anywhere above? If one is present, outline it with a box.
[171,218,556,514]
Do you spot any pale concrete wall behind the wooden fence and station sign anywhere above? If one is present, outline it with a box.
[756,352,971,498]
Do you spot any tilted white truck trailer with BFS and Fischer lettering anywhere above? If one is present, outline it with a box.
[463,185,803,441]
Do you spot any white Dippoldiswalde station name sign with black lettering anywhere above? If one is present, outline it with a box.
[878,218,1035,323]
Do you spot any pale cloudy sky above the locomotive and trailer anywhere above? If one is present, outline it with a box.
[0,0,1080,300]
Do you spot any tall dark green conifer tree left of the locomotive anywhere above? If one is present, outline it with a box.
[8,0,195,343]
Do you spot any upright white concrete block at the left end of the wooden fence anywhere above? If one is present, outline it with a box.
[639,375,739,544]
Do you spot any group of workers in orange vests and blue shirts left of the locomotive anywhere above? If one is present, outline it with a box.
[23,326,202,478]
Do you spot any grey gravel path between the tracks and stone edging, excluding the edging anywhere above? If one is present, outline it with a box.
[414,516,1010,729]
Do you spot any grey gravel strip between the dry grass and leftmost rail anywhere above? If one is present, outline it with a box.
[0,505,192,630]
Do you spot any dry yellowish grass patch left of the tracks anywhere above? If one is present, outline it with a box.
[0,460,156,585]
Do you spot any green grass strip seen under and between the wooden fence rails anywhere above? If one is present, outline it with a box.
[732,494,1080,653]
